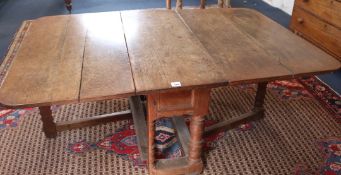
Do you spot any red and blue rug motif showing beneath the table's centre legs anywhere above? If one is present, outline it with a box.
[68,118,225,166]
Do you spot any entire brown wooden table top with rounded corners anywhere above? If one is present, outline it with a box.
[0,8,340,107]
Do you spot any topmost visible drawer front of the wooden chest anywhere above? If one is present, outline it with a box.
[295,0,341,28]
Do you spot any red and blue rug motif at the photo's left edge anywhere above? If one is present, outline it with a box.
[0,109,28,130]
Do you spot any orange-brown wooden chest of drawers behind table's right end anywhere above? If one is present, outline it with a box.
[290,0,341,61]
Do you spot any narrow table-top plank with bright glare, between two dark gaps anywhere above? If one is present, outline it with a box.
[79,12,135,101]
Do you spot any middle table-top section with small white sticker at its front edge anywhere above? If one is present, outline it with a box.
[122,10,227,93]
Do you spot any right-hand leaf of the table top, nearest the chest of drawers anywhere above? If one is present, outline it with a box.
[179,9,340,84]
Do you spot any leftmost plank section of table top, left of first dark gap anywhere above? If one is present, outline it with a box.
[0,16,85,106]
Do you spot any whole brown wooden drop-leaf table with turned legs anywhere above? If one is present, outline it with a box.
[0,9,340,174]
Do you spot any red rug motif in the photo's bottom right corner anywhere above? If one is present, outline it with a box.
[295,138,341,175]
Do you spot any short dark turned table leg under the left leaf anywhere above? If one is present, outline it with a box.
[39,106,57,138]
